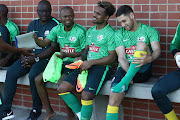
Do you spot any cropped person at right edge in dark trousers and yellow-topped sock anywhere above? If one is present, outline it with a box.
[151,24,180,120]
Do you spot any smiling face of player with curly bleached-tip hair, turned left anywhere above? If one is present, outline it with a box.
[92,6,107,24]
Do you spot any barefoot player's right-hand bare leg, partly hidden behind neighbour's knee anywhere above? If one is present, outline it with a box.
[58,74,75,120]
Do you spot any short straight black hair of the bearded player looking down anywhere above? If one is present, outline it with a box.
[116,5,134,17]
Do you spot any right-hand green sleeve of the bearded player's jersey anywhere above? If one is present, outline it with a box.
[149,27,160,42]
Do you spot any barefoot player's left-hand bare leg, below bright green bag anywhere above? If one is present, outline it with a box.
[35,73,56,120]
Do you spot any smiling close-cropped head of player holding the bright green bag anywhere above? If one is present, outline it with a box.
[60,9,74,27]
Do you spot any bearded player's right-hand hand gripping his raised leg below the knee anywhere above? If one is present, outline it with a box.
[132,53,148,68]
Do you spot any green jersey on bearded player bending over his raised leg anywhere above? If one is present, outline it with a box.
[115,22,160,63]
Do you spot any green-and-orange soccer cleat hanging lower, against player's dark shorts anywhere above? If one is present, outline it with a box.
[76,70,88,92]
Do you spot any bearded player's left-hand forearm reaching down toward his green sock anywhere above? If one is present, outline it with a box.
[116,46,129,72]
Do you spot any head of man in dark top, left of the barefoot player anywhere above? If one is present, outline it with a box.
[37,3,51,22]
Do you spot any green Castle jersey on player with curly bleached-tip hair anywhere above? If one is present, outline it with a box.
[86,24,115,60]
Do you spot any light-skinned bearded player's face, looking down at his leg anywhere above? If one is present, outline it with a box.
[117,14,134,31]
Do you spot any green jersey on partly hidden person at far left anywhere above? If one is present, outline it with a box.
[5,20,19,44]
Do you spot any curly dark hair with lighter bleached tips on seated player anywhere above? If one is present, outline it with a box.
[97,1,116,17]
